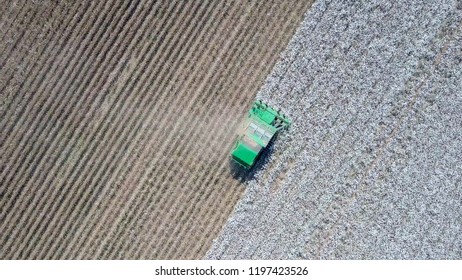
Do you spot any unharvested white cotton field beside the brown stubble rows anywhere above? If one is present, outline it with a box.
[207,0,462,259]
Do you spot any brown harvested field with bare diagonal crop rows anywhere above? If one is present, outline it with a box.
[0,0,311,259]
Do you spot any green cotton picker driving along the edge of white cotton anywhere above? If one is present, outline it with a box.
[231,101,290,169]
